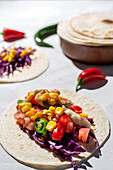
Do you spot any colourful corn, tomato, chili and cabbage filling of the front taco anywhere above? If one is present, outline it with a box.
[14,89,98,168]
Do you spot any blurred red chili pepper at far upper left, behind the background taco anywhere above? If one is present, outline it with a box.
[1,28,25,41]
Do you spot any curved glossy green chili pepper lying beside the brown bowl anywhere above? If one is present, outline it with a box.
[34,24,57,48]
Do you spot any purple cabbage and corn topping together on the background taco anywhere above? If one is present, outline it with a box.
[0,47,35,77]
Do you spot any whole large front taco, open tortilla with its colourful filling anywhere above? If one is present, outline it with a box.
[0,89,109,169]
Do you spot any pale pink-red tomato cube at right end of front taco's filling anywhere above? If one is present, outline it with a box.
[78,128,90,143]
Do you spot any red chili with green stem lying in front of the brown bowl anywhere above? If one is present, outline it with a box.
[76,68,106,91]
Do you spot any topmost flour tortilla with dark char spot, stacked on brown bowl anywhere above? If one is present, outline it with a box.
[70,13,113,39]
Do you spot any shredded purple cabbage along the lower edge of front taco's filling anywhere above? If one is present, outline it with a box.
[21,126,100,169]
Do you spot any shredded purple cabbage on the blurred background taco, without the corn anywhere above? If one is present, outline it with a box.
[0,47,35,77]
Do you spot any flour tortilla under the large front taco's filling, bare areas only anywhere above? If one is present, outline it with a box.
[0,89,110,169]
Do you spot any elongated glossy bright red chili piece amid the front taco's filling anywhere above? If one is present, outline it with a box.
[52,115,68,140]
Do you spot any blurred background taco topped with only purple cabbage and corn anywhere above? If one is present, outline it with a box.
[0,47,49,83]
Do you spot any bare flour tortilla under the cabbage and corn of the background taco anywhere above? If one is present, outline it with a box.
[0,49,49,83]
